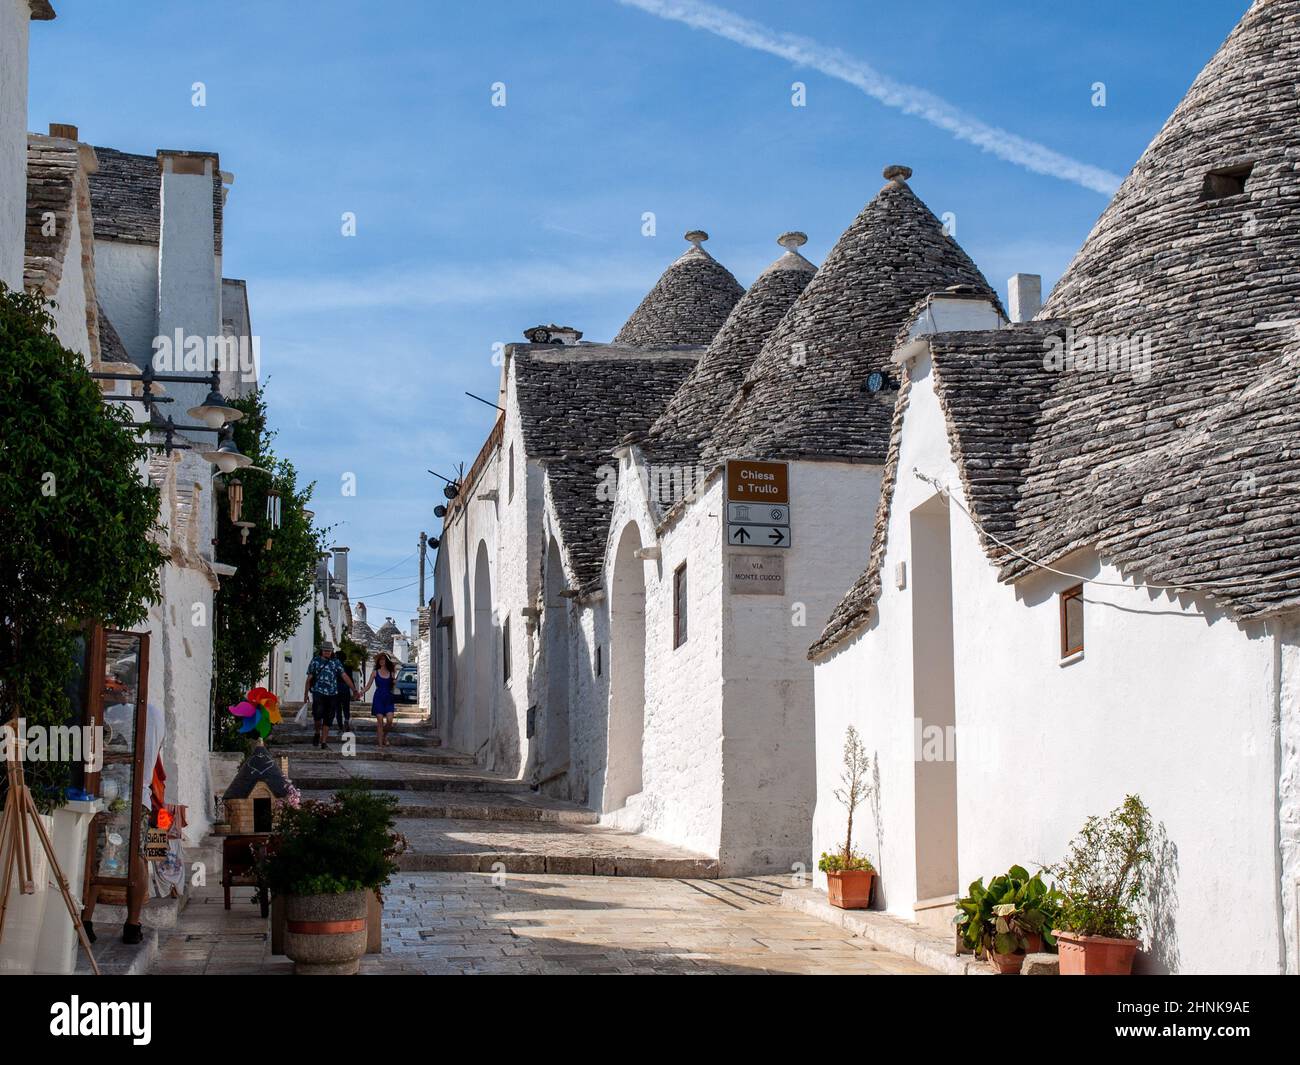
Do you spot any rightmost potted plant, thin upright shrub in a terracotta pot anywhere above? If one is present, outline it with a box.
[1050,795,1152,977]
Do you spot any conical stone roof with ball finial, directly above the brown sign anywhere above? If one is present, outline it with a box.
[703,166,996,463]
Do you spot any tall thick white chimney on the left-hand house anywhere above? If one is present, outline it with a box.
[157,151,221,434]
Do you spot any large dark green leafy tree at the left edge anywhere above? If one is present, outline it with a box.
[0,283,165,811]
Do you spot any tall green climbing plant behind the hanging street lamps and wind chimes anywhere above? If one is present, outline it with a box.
[213,388,326,750]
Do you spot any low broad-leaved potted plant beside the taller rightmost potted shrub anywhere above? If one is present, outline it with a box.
[956,865,1061,975]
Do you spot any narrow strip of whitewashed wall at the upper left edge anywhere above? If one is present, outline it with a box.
[0,0,31,291]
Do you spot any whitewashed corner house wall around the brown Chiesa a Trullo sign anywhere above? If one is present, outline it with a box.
[592,449,880,873]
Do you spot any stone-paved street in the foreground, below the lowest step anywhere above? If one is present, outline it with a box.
[153,873,930,975]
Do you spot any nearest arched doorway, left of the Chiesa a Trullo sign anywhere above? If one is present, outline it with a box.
[603,523,646,810]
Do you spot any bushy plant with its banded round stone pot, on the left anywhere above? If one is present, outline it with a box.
[260,782,406,975]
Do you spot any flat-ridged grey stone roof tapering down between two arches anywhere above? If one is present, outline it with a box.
[510,345,701,590]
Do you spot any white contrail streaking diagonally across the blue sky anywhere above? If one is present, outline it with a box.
[619,0,1122,196]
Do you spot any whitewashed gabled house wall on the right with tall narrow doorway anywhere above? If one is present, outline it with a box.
[814,356,1297,973]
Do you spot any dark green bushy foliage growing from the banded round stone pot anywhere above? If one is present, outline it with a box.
[260,780,406,895]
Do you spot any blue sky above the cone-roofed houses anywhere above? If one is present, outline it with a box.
[29,0,1248,624]
